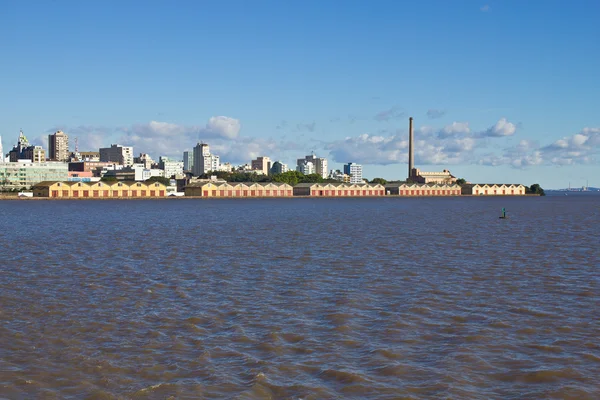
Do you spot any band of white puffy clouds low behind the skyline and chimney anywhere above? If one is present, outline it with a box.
[42,114,600,169]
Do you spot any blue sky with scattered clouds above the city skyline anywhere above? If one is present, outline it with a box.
[0,0,600,188]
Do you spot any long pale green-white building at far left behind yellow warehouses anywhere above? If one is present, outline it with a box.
[0,160,69,189]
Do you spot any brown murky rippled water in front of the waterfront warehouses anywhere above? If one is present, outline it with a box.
[0,196,600,399]
